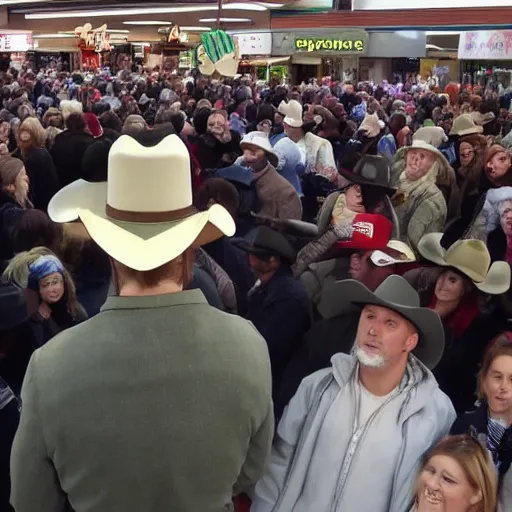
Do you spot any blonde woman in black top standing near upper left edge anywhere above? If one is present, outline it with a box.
[15,117,60,211]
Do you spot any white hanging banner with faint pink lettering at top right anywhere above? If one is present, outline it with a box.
[459,30,512,60]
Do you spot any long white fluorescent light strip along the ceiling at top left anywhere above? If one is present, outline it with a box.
[25,3,268,20]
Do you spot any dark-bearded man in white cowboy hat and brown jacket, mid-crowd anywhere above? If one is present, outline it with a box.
[240,132,302,220]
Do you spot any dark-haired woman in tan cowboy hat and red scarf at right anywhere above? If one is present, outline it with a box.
[404,233,510,412]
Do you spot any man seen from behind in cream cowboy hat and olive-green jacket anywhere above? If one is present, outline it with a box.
[11,135,274,512]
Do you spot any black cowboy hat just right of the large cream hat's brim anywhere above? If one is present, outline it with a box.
[233,226,297,265]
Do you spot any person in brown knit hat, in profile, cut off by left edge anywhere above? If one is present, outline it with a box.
[0,156,32,264]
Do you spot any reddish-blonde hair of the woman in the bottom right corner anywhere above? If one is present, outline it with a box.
[420,434,498,512]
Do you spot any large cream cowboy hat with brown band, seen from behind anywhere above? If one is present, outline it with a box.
[48,135,235,271]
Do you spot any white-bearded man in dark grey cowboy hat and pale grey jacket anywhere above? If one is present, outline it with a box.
[251,276,455,512]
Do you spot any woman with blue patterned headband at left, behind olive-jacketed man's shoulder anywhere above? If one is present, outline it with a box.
[2,247,87,345]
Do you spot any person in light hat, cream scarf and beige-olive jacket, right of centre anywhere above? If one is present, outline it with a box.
[392,140,457,250]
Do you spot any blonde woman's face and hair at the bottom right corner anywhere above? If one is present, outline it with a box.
[411,435,498,512]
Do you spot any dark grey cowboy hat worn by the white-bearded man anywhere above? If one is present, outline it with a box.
[317,274,444,370]
